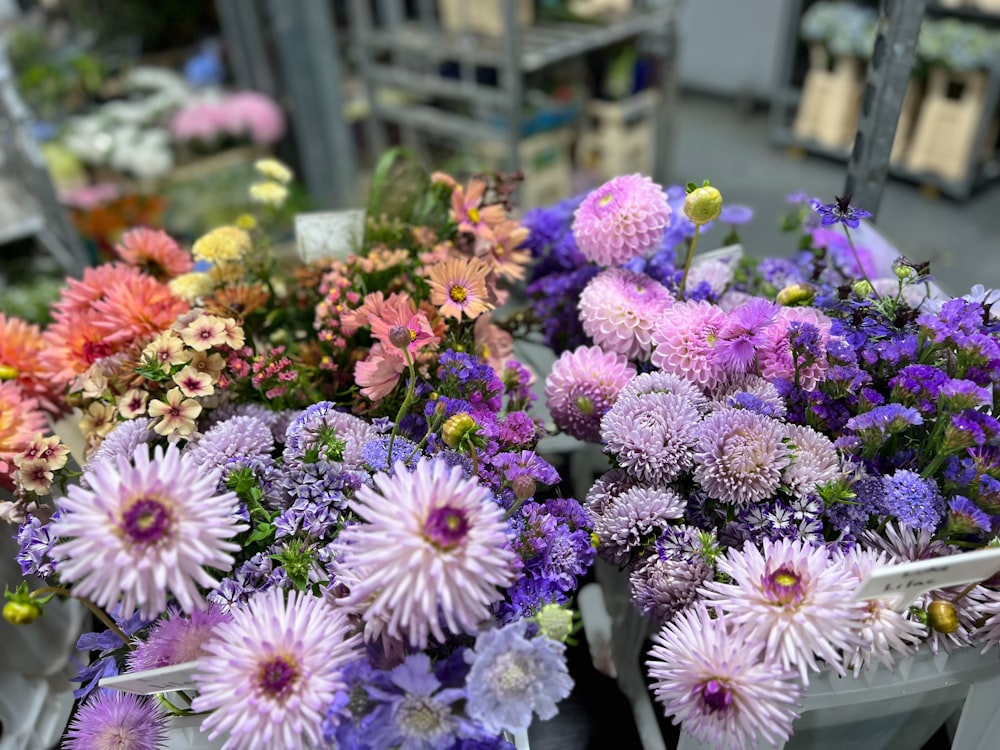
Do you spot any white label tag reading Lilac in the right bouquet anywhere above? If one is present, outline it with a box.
[854,547,1000,610]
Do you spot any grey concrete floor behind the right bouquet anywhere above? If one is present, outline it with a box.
[671,94,1000,294]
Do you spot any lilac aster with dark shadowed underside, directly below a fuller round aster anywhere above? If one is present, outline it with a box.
[594,487,686,566]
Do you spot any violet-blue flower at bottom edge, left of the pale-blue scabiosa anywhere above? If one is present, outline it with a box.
[368,652,471,750]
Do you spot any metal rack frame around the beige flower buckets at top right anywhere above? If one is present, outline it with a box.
[771,0,1000,200]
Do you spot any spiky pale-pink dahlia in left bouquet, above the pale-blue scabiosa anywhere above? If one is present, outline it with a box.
[336,459,518,648]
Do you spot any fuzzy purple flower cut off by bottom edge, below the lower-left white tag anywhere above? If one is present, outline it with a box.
[62,690,167,750]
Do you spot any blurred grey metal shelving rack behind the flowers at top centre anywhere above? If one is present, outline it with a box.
[350,0,677,187]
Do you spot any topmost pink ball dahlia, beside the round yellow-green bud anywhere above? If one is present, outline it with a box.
[573,174,671,266]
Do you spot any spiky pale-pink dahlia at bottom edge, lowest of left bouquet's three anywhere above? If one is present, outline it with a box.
[191,587,360,750]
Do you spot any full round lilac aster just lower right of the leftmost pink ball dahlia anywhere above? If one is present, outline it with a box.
[601,393,701,485]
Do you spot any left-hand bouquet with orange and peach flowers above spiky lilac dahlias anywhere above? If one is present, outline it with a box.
[0,155,595,750]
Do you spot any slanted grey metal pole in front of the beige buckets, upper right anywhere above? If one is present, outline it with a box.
[844,0,927,218]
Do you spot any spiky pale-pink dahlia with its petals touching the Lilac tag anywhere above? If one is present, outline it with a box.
[704,539,863,685]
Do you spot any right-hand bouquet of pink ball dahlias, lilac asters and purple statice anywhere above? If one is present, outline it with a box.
[526,175,1000,748]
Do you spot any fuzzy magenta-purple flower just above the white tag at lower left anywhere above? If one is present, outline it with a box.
[126,606,231,672]
